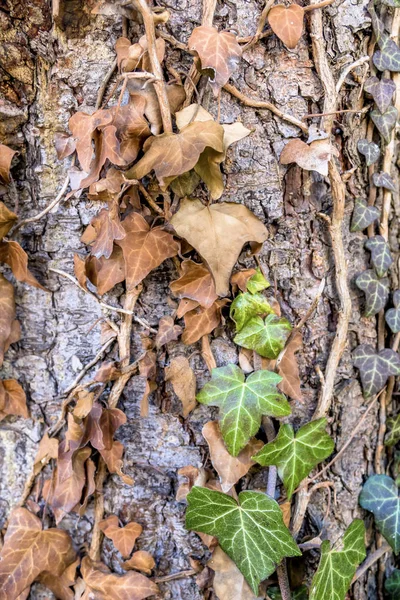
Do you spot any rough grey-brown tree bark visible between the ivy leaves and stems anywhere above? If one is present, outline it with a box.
[0,0,390,600]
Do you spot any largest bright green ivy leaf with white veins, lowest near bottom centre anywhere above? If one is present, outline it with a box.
[186,487,301,596]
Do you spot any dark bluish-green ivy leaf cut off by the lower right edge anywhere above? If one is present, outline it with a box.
[359,475,400,554]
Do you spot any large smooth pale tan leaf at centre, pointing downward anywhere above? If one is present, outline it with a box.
[171,198,268,296]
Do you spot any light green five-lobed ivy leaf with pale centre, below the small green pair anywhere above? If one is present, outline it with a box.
[197,365,291,456]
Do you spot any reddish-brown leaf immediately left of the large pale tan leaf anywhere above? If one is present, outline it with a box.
[117,213,179,290]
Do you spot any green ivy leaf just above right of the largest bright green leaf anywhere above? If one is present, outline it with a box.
[252,419,335,500]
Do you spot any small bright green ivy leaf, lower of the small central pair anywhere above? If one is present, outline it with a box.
[233,315,292,358]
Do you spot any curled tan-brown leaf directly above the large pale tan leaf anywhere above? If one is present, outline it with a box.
[126,121,224,190]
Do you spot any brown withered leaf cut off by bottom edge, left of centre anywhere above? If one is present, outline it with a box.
[81,556,158,600]
